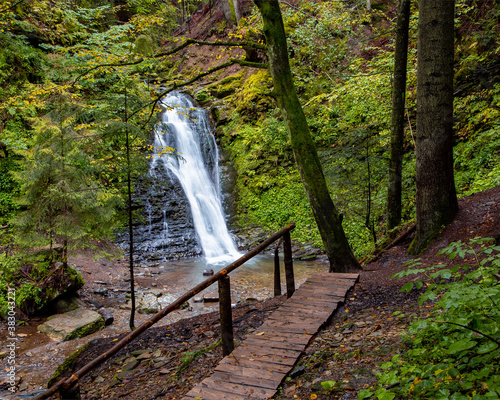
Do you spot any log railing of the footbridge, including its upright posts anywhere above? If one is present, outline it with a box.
[34,223,295,400]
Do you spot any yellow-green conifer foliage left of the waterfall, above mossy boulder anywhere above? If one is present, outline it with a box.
[14,104,123,252]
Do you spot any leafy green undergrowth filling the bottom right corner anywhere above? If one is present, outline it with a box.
[359,238,500,399]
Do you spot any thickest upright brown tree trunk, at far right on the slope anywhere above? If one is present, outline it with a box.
[408,0,458,254]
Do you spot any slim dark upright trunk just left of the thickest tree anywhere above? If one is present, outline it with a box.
[387,0,411,229]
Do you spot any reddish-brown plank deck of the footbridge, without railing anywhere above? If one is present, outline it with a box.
[179,273,359,400]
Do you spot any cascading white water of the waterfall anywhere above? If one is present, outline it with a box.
[151,92,240,263]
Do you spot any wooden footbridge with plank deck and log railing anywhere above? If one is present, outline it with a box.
[34,224,358,400]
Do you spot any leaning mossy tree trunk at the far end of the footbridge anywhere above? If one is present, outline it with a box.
[254,0,361,272]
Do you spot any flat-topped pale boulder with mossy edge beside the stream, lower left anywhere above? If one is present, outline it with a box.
[38,308,104,341]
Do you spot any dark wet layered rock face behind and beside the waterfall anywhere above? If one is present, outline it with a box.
[116,92,242,263]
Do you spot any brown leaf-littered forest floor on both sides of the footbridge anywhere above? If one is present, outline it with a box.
[29,187,500,400]
